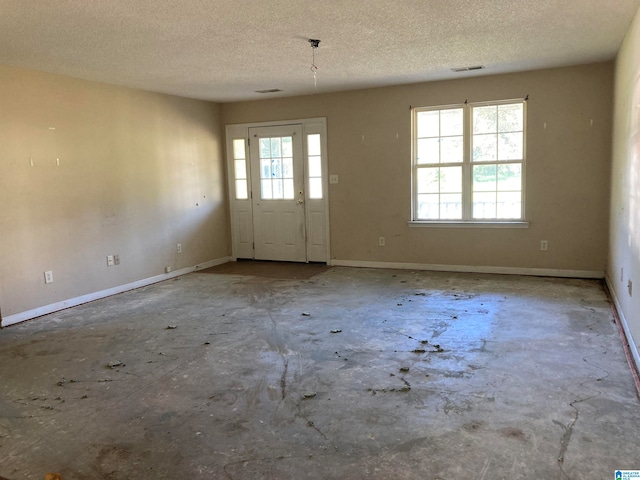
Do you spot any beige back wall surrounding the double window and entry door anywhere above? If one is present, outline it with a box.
[222,62,613,273]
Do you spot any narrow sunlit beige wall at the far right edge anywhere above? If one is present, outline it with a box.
[607,6,640,346]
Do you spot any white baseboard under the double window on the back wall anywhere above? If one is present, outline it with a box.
[330,260,604,279]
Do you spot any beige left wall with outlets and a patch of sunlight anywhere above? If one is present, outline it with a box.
[0,63,230,318]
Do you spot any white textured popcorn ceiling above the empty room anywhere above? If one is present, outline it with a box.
[0,0,640,102]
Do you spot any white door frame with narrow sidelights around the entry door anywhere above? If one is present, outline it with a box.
[225,117,331,264]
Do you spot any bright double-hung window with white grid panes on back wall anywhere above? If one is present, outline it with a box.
[412,100,526,223]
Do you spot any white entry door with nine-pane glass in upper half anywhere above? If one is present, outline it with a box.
[249,125,307,262]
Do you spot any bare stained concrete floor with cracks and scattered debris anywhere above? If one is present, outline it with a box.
[0,265,640,480]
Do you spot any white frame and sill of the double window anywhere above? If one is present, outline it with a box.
[408,98,529,228]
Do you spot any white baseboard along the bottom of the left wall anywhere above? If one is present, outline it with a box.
[0,257,231,327]
